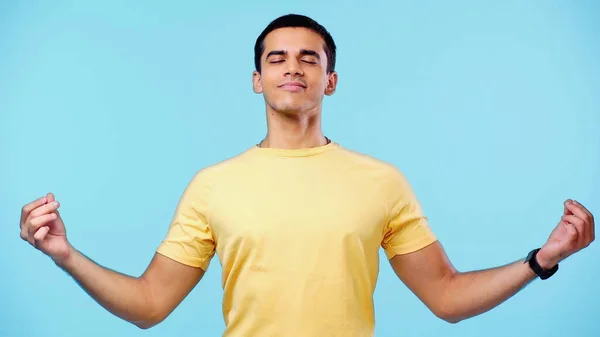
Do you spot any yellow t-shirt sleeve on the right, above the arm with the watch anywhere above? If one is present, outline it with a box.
[382,170,437,259]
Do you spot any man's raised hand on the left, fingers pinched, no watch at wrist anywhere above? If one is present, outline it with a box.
[20,193,70,264]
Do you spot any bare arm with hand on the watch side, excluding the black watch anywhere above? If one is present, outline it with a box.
[390,201,595,323]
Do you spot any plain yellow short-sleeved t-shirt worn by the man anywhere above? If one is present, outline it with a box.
[157,142,436,337]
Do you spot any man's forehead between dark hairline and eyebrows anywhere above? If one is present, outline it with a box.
[263,27,325,56]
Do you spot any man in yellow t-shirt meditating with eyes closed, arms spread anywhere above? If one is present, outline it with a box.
[21,15,594,337]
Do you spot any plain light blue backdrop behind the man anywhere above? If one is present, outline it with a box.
[0,1,600,337]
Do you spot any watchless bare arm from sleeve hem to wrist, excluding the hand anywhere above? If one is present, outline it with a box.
[57,248,204,329]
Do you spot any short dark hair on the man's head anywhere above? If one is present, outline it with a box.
[254,14,336,73]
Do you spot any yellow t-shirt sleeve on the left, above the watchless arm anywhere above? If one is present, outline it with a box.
[156,172,215,271]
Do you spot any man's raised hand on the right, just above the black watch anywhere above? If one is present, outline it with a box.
[537,199,595,270]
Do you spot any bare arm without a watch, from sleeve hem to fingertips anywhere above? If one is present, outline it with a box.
[20,194,204,329]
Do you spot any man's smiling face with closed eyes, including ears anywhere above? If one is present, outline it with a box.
[253,28,337,115]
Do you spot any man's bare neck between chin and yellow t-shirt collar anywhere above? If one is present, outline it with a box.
[259,103,328,149]
